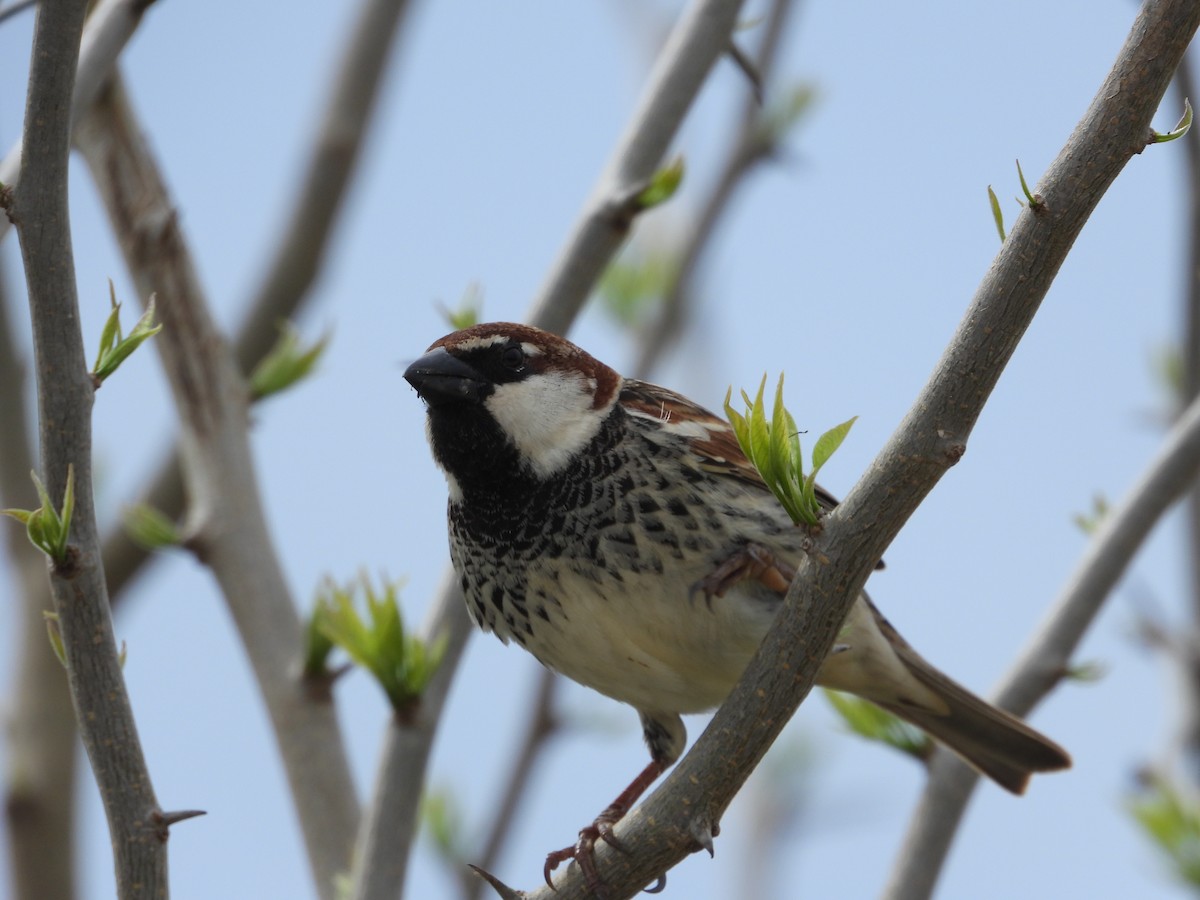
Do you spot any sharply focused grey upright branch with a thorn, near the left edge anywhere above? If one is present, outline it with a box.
[11,0,168,900]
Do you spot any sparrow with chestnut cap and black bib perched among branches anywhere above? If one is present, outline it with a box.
[404,322,1070,893]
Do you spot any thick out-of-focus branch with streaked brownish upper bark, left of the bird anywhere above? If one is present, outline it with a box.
[79,74,359,900]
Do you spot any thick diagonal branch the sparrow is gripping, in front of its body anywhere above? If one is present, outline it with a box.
[482,0,1200,900]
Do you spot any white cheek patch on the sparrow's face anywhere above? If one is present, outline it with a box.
[485,370,611,478]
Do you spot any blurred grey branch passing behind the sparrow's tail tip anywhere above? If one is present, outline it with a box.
[884,374,1200,900]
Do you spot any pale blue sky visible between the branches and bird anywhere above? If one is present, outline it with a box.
[0,0,1186,900]
